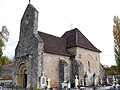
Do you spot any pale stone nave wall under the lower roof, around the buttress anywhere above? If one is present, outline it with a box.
[43,53,71,87]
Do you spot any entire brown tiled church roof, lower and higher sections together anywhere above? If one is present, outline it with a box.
[38,28,101,56]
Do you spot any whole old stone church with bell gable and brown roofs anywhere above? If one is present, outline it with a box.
[13,4,101,90]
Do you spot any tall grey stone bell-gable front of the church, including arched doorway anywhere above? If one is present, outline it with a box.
[14,3,43,90]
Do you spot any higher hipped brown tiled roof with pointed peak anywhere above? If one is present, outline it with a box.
[62,28,101,52]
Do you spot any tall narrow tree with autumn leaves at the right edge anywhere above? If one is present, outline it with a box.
[113,16,120,72]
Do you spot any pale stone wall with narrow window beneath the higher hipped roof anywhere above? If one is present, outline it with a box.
[75,48,100,84]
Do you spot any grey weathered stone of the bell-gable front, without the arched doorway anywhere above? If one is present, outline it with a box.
[14,4,44,88]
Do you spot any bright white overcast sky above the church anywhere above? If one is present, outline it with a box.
[0,0,120,66]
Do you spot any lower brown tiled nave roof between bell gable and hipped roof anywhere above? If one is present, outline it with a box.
[38,32,69,56]
